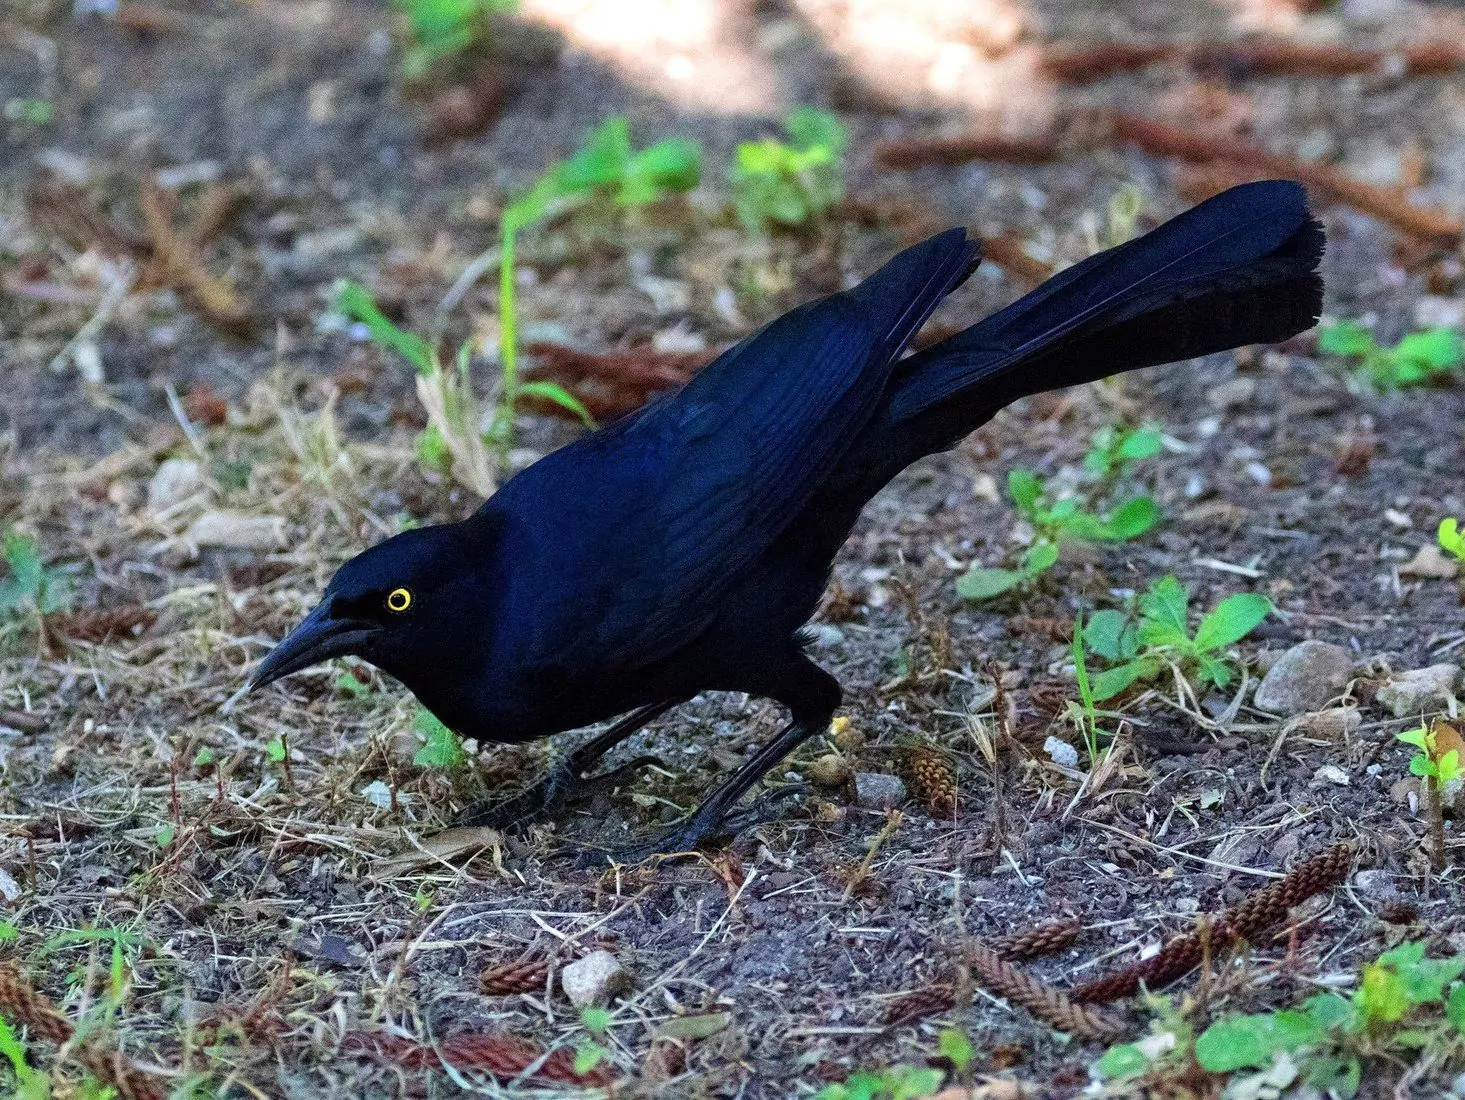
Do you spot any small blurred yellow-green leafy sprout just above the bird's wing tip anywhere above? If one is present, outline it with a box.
[728,107,850,236]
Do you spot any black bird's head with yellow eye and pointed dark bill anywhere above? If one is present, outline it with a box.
[248,524,466,690]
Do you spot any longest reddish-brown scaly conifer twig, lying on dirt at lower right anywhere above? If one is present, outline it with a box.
[1071,844,1354,1005]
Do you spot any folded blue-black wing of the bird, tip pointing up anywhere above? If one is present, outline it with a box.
[488,230,976,668]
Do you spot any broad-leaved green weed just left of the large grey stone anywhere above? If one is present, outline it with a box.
[1083,576,1272,703]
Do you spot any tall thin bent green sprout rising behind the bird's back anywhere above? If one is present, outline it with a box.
[492,116,702,439]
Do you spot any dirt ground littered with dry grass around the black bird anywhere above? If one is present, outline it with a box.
[0,0,1465,1097]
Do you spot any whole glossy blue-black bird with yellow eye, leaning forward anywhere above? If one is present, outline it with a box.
[253,182,1323,850]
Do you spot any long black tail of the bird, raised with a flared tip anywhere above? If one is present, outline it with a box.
[863,180,1323,488]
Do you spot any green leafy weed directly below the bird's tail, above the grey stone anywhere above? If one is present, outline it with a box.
[957,454,1160,601]
